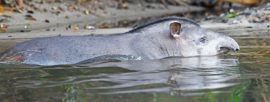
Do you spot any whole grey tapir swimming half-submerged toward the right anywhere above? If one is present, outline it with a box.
[0,17,240,65]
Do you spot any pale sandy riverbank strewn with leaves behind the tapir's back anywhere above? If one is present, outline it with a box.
[0,0,203,33]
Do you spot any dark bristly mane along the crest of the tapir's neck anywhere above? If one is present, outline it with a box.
[129,16,200,32]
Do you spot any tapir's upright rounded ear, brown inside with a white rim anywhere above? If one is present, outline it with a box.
[170,22,181,39]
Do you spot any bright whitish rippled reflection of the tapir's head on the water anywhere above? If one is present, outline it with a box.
[84,56,240,94]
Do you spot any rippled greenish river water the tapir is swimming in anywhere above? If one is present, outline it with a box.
[0,31,270,102]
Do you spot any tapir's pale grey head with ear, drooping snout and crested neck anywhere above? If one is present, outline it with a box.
[130,17,240,56]
